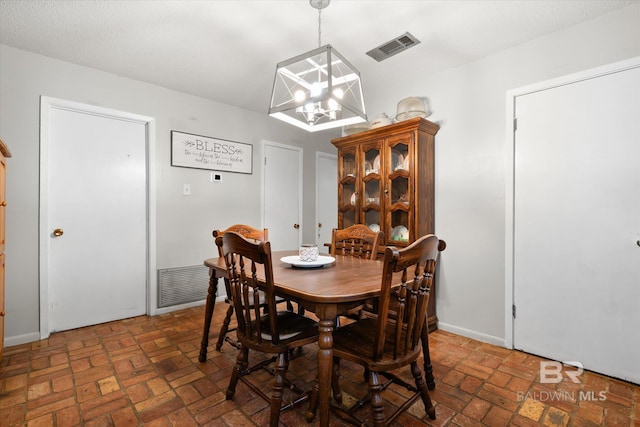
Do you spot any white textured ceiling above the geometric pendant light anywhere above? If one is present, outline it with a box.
[0,0,639,116]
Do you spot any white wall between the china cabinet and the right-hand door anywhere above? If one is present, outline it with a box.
[365,5,640,344]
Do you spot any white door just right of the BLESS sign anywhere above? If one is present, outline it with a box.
[263,143,302,251]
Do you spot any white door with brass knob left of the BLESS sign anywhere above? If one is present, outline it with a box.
[40,98,148,336]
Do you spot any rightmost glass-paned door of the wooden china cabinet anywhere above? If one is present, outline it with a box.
[385,135,415,246]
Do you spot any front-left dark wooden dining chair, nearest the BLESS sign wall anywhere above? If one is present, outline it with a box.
[216,232,318,427]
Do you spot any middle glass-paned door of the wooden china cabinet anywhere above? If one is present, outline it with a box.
[360,140,383,231]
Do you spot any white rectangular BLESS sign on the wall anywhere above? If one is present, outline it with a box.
[171,130,253,173]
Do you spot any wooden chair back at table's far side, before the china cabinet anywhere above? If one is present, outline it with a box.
[330,224,384,259]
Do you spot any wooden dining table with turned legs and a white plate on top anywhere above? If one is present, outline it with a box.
[199,251,390,426]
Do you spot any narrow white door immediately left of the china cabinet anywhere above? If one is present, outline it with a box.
[316,153,338,253]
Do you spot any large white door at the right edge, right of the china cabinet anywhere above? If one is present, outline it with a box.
[513,64,640,383]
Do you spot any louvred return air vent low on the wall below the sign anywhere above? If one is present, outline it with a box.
[158,265,209,308]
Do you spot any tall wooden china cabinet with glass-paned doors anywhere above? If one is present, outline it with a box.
[331,117,444,330]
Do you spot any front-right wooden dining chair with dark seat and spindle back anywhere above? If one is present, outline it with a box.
[307,234,439,426]
